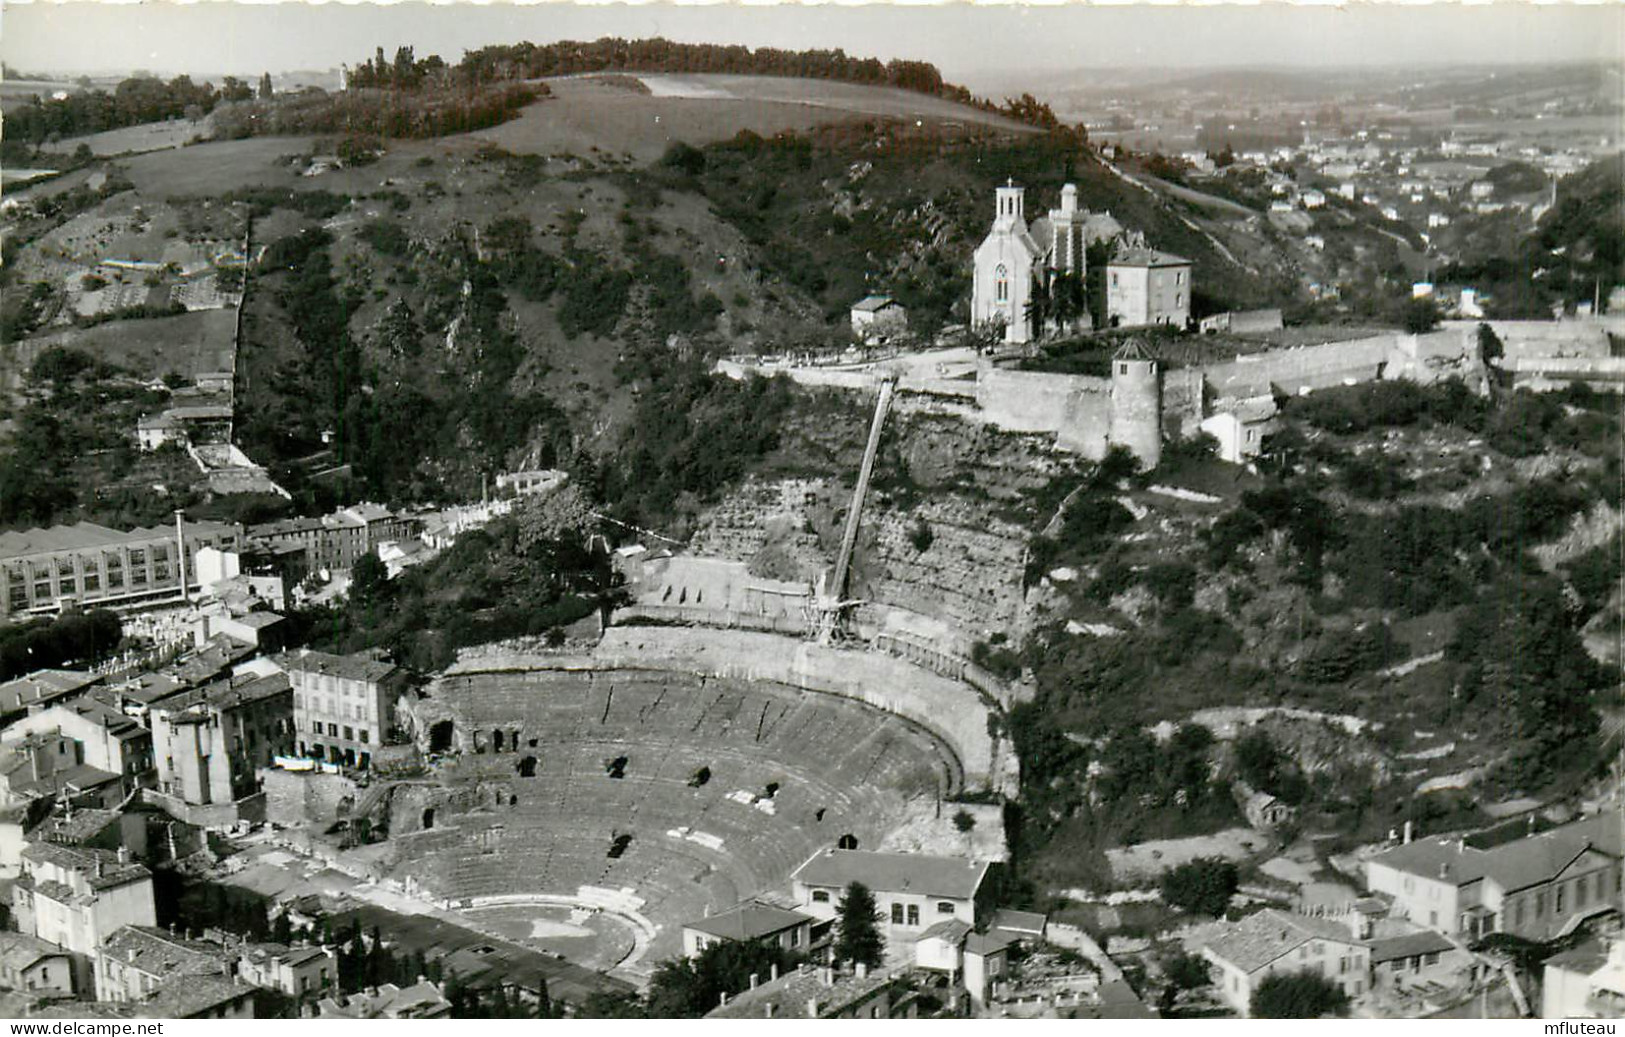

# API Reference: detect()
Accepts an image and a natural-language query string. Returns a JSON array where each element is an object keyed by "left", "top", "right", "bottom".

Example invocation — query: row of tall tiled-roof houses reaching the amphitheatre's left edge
[{"left": 0, "top": 637, "right": 408, "bottom": 832}]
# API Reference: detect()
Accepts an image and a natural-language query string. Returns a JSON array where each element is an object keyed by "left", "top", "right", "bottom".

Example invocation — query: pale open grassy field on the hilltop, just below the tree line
[{"left": 470, "top": 75, "right": 1025, "bottom": 163}]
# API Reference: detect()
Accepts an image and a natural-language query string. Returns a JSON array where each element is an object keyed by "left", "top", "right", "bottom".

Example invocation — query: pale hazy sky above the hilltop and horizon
[{"left": 0, "top": 0, "right": 1625, "bottom": 88}]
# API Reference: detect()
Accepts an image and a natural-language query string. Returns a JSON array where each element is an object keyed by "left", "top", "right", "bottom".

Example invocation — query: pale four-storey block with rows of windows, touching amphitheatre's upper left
[{"left": 275, "top": 649, "right": 406, "bottom": 769}]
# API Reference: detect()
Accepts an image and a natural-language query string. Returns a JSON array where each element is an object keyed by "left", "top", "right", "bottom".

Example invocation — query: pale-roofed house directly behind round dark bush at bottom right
[{"left": 1203, "top": 907, "right": 1372, "bottom": 1014}]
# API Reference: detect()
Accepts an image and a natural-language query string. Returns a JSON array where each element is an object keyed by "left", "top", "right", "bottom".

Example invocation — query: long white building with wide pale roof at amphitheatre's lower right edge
[{"left": 790, "top": 850, "right": 993, "bottom": 946}]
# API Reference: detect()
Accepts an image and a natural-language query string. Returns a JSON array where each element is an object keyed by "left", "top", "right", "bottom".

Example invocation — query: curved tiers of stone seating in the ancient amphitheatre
[{"left": 392, "top": 670, "right": 960, "bottom": 961}]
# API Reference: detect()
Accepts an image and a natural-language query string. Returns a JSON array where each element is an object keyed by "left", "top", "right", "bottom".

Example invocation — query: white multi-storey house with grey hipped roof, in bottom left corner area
[{"left": 11, "top": 842, "right": 158, "bottom": 991}]
